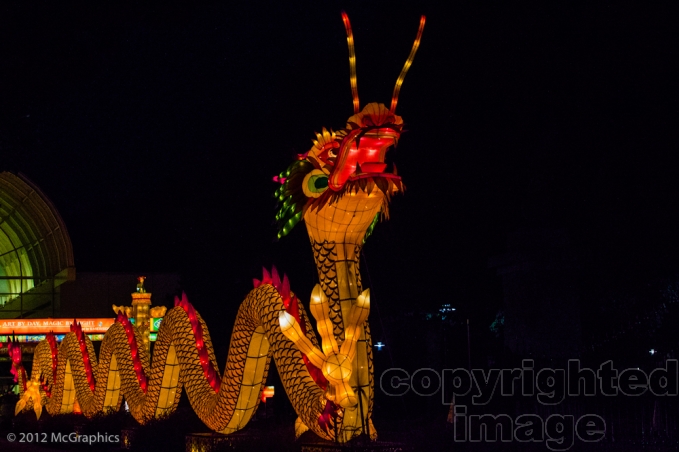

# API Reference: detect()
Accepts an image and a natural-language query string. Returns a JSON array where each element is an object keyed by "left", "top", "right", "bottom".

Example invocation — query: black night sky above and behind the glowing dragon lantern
[{"left": 0, "top": 1, "right": 679, "bottom": 350}]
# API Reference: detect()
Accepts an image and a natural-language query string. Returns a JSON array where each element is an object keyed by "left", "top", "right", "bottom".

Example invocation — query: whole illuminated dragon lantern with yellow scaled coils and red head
[{"left": 13, "top": 13, "right": 425, "bottom": 442}]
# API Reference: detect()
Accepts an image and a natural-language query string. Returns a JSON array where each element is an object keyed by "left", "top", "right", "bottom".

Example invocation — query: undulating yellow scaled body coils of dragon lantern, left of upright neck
[{"left": 19, "top": 284, "right": 328, "bottom": 437}]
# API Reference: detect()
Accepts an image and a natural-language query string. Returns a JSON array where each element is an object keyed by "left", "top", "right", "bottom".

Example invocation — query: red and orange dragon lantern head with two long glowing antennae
[{"left": 274, "top": 13, "right": 425, "bottom": 245}]
